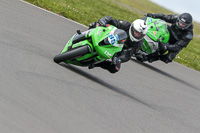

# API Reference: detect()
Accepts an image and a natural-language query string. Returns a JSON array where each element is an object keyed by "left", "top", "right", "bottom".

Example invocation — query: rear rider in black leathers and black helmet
[{"left": 147, "top": 13, "right": 193, "bottom": 63}]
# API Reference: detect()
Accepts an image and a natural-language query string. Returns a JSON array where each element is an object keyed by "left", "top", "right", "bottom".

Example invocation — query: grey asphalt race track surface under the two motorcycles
[{"left": 0, "top": 0, "right": 200, "bottom": 133}]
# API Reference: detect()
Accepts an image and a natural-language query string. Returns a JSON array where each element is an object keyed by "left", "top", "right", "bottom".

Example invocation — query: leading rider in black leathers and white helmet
[{"left": 89, "top": 16, "right": 147, "bottom": 73}]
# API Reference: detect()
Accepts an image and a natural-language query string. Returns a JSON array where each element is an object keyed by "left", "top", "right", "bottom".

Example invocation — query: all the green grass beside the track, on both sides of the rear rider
[{"left": 25, "top": 0, "right": 200, "bottom": 71}]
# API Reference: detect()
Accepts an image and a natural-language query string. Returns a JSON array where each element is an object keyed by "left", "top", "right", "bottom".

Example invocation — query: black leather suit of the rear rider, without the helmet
[{"left": 149, "top": 14, "right": 193, "bottom": 63}]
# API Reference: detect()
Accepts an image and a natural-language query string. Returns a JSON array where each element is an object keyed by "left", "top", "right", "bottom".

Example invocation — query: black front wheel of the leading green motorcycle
[{"left": 53, "top": 45, "right": 90, "bottom": 63}]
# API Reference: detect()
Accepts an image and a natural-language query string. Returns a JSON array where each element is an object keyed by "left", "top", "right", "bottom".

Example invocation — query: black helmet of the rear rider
[{"left": 176, "top": 13, "right": 192, "bottom": 30}]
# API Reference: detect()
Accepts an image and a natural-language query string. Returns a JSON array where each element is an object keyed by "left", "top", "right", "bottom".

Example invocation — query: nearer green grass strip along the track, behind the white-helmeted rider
[{"left": 26, "top": 0, "right": 139, "bottom": 26}]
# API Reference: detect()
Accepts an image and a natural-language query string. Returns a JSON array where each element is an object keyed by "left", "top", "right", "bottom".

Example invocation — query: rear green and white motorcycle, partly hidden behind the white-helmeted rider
[{"left": 134, "top": 17, "right": 170, "bottom": 61}]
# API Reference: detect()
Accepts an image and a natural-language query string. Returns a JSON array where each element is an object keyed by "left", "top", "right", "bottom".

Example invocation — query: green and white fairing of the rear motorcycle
[{"left": 142, "top": 17, "right": 170, "bottom": 54}]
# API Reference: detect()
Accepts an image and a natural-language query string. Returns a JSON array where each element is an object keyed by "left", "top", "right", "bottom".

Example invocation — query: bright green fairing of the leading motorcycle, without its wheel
[{"left": 55, "top": 25, "right": 126, "bottom": 66}]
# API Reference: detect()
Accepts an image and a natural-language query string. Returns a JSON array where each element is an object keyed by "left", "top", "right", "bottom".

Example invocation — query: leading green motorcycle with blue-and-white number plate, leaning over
[{"left": 54, "top": 25, "right": 128, "bottom": 67}]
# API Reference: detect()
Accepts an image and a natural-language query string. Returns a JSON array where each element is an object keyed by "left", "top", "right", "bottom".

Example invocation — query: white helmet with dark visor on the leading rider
[{"left": 129, "top": 19, "right": 147, "bottom": 42}]
